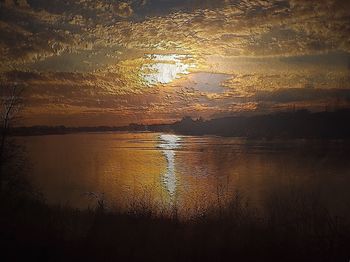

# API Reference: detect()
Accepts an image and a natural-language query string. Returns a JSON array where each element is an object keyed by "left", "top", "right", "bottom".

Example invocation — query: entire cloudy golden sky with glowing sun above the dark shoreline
[{"left": 0, "top": 0, "right": 350, "bottom": 126}]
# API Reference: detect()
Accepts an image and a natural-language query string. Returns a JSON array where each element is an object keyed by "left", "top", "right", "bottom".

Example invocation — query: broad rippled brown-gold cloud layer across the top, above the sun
[{"left": 0, "top": 0, "right": 350, "bottom": 70}]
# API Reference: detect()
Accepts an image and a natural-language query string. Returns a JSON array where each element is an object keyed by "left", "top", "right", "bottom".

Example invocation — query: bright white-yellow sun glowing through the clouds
[{"left": 141, "top": 54, "right": 195, "bottom": 86}]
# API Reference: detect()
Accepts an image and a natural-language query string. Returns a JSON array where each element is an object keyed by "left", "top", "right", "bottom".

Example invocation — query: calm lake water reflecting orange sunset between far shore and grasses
[{"left": 19, "top": 133, "right": 350, "bottom": 214}]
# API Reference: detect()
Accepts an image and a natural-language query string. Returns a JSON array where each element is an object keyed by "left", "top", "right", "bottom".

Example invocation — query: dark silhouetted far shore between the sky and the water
[{"left": 6, "top": 110, "right": 350, "bottom": 139}]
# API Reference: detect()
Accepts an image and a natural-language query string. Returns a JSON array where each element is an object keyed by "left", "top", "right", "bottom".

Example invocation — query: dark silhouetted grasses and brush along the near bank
[{"left": 0, "top": 183, "right": 350, "bottom": 261}]
